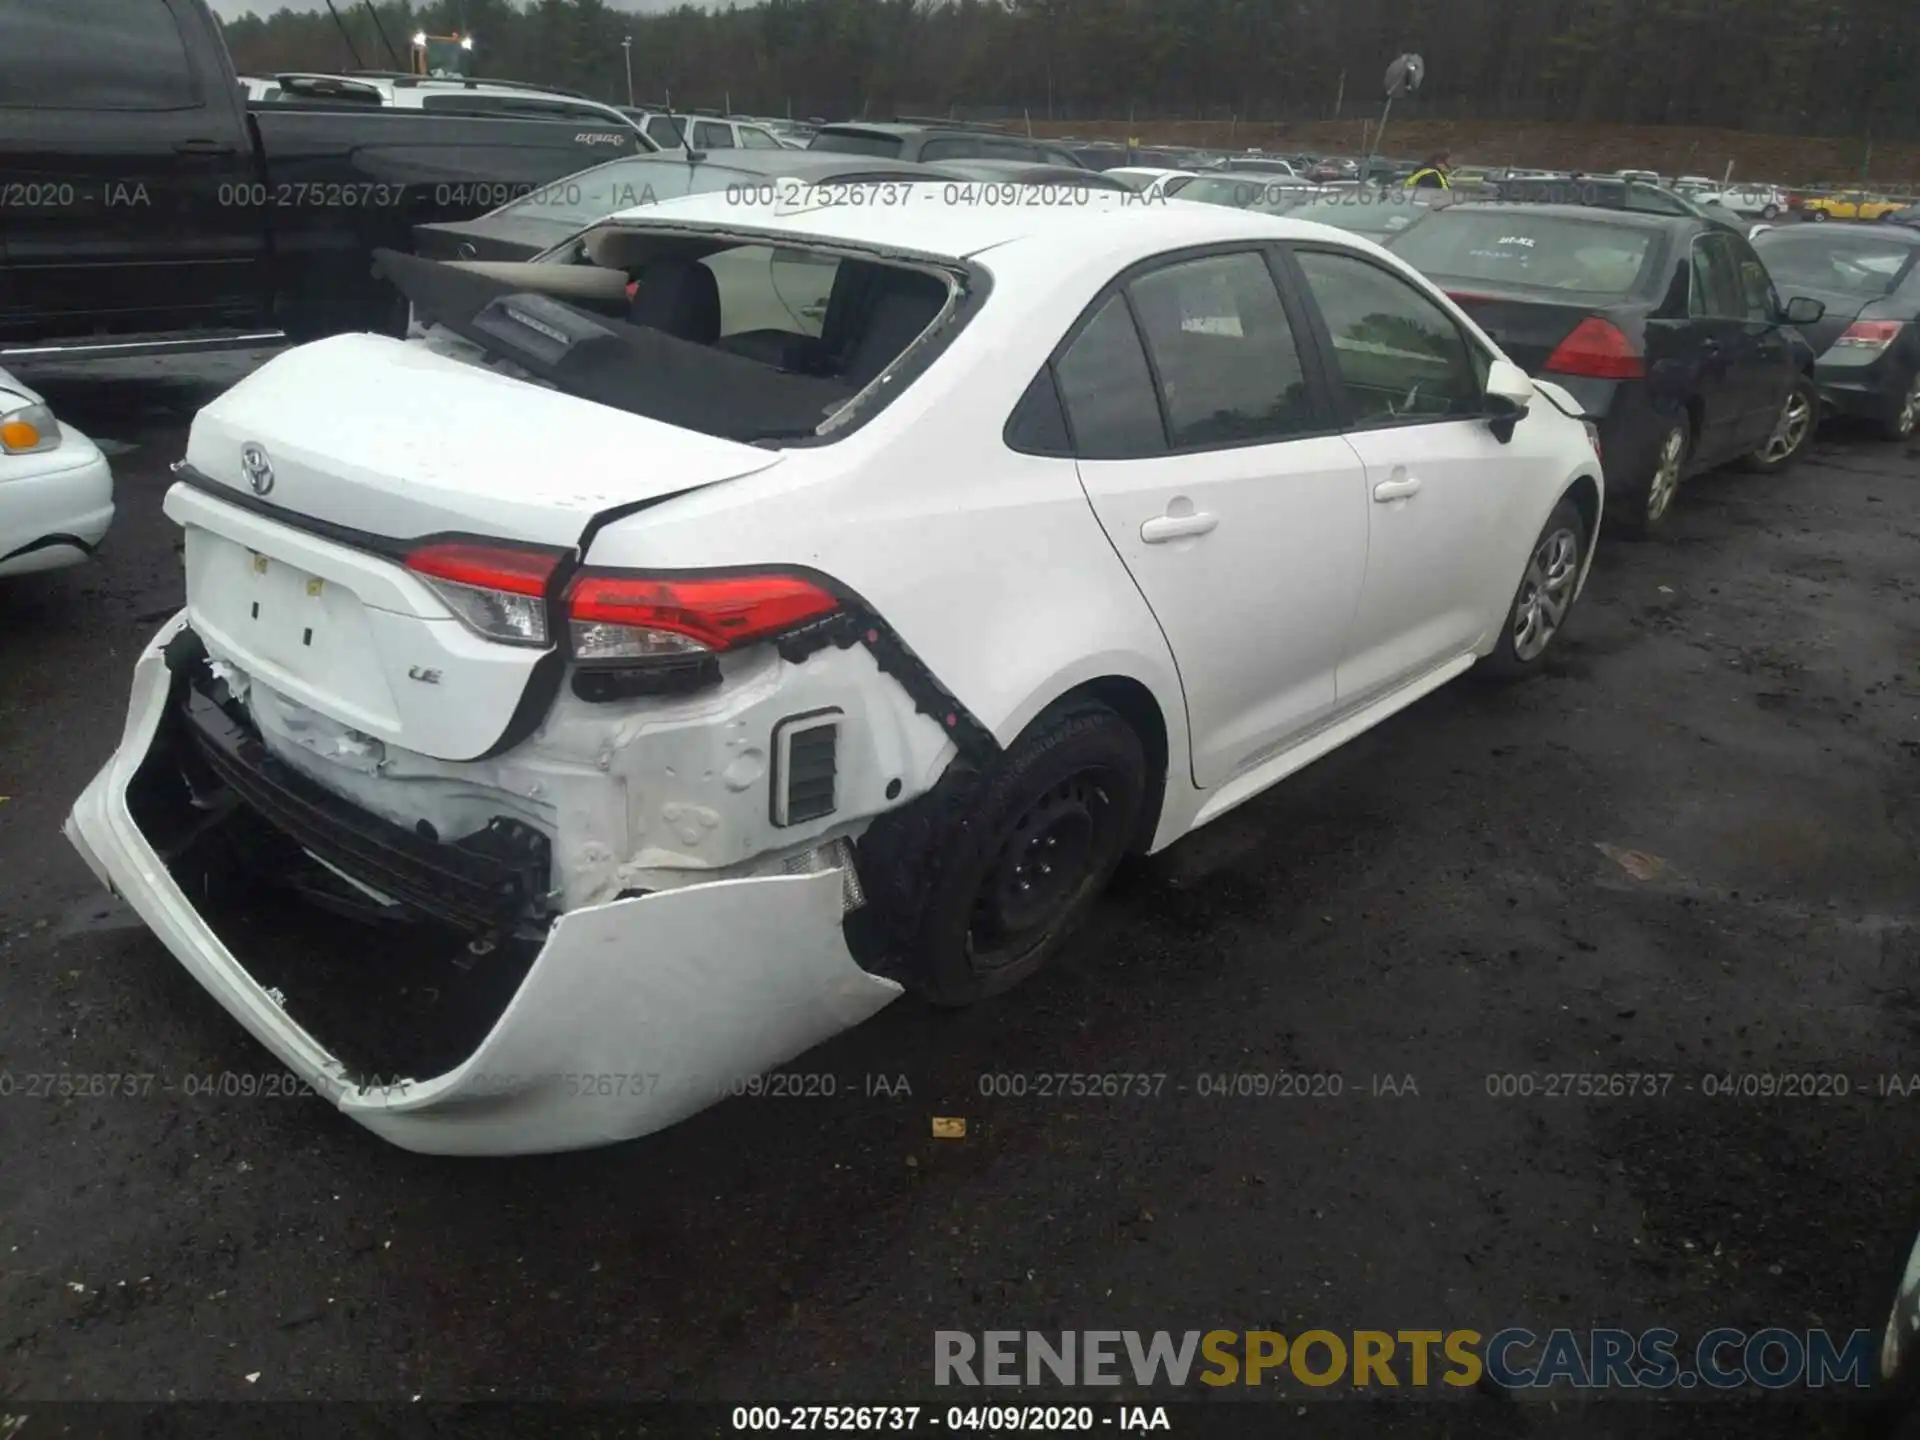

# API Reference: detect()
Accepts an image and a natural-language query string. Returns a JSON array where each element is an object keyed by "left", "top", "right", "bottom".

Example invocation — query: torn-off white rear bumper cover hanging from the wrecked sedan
[{"left": 65, "top": 614, "right": 900, "bottom": 1154}]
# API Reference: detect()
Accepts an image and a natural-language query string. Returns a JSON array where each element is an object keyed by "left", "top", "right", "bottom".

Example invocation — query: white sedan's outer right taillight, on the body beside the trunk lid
[{"left": 566, "top": 570, "right": 839, "bottom": 662}]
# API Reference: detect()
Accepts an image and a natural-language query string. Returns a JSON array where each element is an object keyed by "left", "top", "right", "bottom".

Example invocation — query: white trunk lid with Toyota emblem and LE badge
[{"left": 167, "top": 336, "right": 781, "bottom": 768}]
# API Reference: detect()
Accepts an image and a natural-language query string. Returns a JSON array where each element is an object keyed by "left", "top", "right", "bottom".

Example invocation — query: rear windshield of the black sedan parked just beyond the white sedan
[{"left": 1388, "top": 205, "right": 1659, "bottom": 298}]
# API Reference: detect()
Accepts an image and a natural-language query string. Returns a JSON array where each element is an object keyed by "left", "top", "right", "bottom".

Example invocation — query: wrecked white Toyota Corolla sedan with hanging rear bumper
[{"left": 67, "top": 184, "right": 1601, "bottom": 1154}]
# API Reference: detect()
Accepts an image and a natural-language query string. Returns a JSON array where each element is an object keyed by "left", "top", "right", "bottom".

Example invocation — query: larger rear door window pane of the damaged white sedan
[{"left": 1131, "top": 253, "right": 1315, "bottom": 449}]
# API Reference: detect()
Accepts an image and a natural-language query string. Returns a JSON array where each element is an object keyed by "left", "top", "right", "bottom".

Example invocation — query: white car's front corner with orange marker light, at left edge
[{"left": 0, "top": 371, "right": 113, "bottom": 576}]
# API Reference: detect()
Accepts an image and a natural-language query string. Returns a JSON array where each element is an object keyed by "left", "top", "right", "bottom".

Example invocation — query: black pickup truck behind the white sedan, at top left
[{"left": 0, "top": 0, "right": 653, "bottom": 365}]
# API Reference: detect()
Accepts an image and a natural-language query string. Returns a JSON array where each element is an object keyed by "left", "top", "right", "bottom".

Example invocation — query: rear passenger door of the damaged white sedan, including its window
[{"left": 1054, "top": 248, "right": 1367, "bottom": 787}]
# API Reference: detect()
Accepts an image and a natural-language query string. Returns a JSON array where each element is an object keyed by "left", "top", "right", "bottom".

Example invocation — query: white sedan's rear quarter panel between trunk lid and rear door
[{"left": 588, "top": 263, "right": 1187, "bottom": 844}]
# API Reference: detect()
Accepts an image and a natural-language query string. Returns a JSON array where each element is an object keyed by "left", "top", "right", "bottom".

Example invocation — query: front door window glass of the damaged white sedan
[{"left": 1296, "top": 250, "right": 1484, "bottom": 426}]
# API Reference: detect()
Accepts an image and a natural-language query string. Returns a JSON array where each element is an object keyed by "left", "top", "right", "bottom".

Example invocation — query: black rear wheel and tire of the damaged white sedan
[{"left": 904, "top": 701, "right": 1146, "bottom": 1008}]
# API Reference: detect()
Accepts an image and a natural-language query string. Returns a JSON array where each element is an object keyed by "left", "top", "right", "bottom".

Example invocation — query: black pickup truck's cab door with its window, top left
[{"left": 0, "top": 0, "right": 267, "bottom": 336}]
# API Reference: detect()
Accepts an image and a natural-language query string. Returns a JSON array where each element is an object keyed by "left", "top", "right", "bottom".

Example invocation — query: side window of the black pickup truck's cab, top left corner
[{"left": 0, "top": 0, "right": 200, "bottom": 109}]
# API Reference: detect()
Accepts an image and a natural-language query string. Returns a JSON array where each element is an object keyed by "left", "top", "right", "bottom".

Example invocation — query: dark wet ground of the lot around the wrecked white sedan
[{"left": 0, "top": 353, "right": 1920, "bottom": 1436}]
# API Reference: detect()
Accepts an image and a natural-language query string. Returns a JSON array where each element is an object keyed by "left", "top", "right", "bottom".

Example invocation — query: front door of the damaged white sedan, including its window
[{"left": 1292, "top": 246, "right": 1544, "bottom": 710}]
